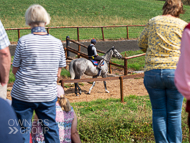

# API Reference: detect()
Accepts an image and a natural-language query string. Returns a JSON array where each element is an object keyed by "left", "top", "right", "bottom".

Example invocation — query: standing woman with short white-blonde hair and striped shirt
[{"left": 11, "top": 4, "right": 66, "bottom": 143}]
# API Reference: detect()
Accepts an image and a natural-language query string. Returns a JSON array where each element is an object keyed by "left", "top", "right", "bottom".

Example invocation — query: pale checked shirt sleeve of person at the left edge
[{"left": 0, "top": 21, "right": 10, "bottom": 50}]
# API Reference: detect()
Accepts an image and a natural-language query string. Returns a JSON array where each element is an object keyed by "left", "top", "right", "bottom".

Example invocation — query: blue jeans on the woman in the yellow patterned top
[{"left": 144, "top": 69, "right": 183, "bottom": 143}]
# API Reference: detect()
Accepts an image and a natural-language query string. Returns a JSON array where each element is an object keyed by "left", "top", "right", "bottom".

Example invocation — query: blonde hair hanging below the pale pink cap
[{"left": 58, "top": 97, "right": 71, "bottom": 112}]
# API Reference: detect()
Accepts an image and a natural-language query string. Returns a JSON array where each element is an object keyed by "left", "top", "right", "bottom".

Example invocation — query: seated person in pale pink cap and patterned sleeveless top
[{"left": 31, "top": 85, "right": 81, "bottom": 143}]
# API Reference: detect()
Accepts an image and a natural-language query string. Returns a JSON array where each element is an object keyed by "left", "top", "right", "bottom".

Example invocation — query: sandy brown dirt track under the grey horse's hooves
[{"left": 7, "top": 69, "right": 148, "bottom": 102}]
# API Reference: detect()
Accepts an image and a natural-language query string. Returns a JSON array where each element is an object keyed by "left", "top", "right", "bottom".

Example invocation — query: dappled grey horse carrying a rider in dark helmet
[{"left": 69, "top": 46, "right": 122, "bottom": 96}]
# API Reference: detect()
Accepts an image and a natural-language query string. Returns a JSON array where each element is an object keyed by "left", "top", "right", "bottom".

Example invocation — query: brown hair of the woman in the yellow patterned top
[{"left": 162, "top": 0, "right": 185, "bottom": 17}]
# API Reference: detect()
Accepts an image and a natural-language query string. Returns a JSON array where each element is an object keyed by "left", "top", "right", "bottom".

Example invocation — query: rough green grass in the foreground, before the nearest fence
[{"left": 72, "top": 95, "right": 188, "bottom": 143}]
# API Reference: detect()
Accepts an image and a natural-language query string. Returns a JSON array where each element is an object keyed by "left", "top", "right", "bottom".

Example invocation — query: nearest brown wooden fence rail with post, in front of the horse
[{"left": 60, "top": 74, "right": 144, "bottom": 103}]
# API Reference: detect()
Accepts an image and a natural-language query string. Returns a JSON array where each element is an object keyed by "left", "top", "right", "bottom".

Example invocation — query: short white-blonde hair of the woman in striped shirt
[{"left": 25, "top": 4, "right": 51, "bottom": 25}]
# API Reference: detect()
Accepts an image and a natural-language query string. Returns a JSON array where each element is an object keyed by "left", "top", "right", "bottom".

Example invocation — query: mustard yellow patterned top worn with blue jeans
[{"left": 138, "top": 16, "right": 187, "bottom": 71}]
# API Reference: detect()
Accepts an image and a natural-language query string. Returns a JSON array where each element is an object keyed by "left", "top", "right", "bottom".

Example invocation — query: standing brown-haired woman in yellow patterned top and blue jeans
[{"left": 138, "top": 0, "right": 187, "bottom": 143}]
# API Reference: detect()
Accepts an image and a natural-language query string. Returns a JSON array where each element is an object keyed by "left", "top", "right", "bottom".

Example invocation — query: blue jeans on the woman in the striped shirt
[{"left": 12, "top": 98, "right": 60, "bottom": 143}]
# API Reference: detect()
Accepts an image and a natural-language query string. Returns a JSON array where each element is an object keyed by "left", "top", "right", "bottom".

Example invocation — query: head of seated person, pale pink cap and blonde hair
[{"left": 57, "top": 85, "right": 71, "bottom": 112}]
